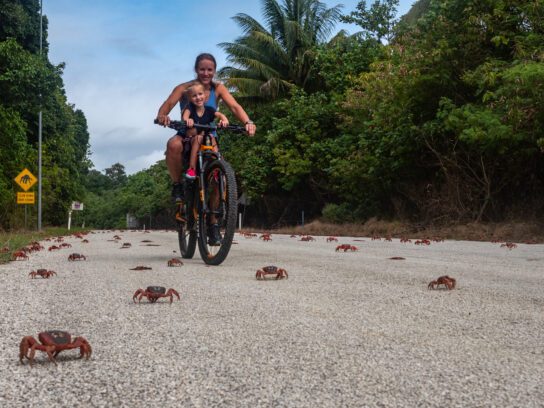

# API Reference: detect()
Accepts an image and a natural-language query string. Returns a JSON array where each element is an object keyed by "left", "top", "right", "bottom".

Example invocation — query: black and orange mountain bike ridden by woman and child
[{"left": 155, "top": 121, "right": 246, "bottom": 265}]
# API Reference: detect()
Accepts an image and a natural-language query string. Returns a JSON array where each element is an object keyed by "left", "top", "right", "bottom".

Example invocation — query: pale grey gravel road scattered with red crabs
[{"left": 0, "top": 231, "right": 544, "bottom": 408}]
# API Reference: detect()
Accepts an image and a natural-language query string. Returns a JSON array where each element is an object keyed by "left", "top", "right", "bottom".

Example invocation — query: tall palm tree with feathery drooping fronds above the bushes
[{"left": 219, "top": 0, "right": 342, "bottom": 98}]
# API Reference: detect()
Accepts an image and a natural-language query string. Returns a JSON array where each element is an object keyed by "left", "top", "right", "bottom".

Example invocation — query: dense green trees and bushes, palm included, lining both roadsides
[{"left": 0, "top": 0, "right": 544, "bottom": 228}]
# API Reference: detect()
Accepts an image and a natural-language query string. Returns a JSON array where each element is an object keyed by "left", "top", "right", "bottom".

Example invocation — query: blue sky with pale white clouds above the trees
[{"left": 42, "top": 0, "right": 415, "bottom": 174}]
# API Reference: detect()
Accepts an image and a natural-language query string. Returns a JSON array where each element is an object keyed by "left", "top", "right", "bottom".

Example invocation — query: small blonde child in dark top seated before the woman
[{"left": 181, "top": 83, "right": 229, "bottom": 180}]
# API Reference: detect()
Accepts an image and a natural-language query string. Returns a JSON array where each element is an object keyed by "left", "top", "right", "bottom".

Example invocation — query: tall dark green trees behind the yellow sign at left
[{"left": 0, "top": 0, "right": 91, "bottom": 228}]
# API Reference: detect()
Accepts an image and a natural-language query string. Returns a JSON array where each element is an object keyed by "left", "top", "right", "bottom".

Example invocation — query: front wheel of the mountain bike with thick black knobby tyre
[{"left": 198, "top": 160, "right": 238, "bottom": 265}]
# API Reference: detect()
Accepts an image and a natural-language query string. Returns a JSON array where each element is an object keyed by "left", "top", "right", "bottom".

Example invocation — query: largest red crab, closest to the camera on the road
[{"left": 19, "top": 330, "right": 92, "bottom": 367}]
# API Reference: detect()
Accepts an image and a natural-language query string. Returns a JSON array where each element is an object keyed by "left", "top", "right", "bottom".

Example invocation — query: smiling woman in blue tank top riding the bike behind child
[{"left": 157, "top": 54, "right": 256, "bottom": 202}]
